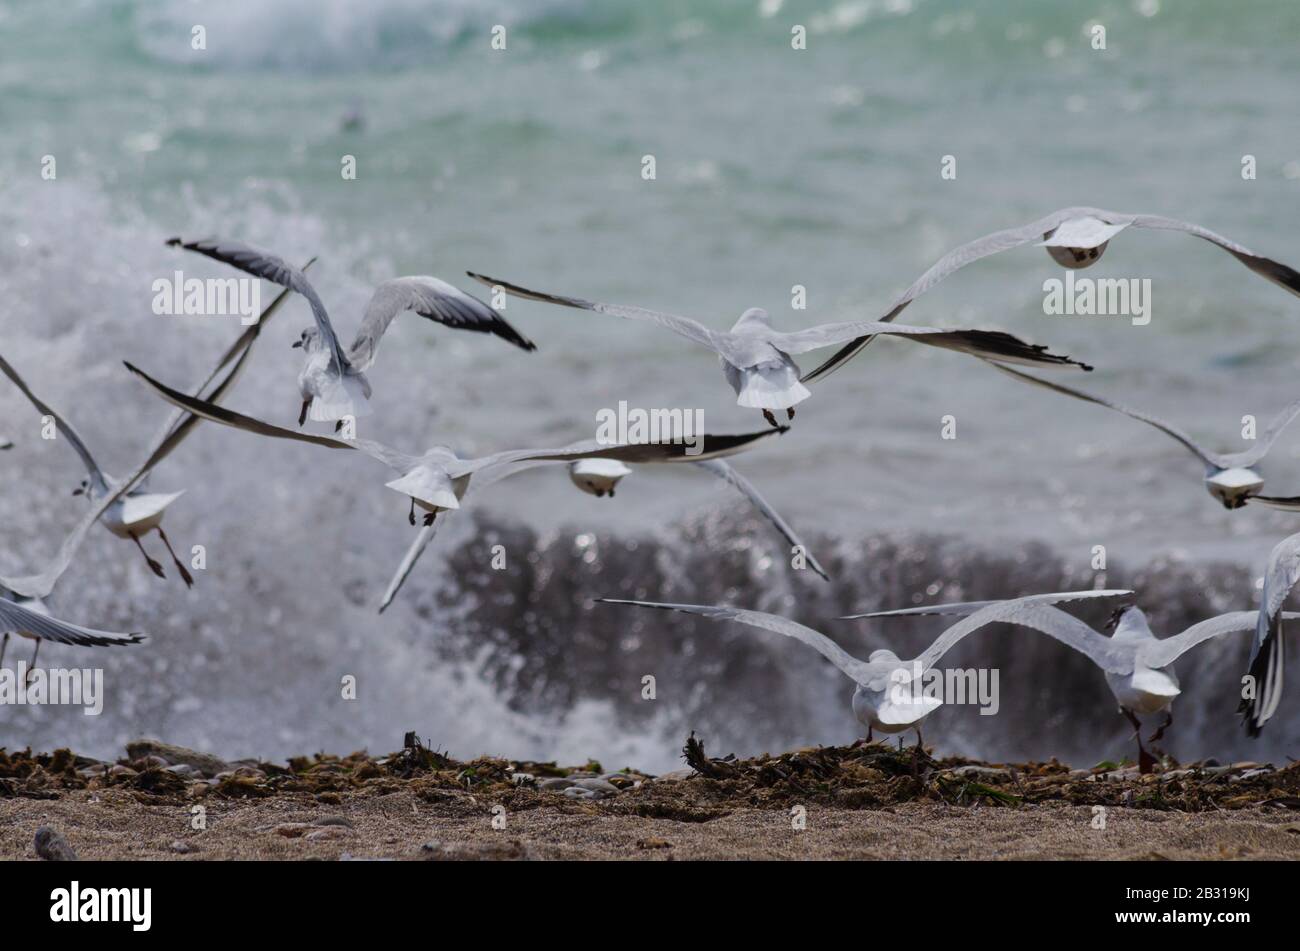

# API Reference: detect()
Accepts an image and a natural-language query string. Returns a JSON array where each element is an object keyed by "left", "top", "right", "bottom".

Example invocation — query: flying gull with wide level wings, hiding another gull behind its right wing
[{"left": 126, "top": 364, "right": 784, "bottom": 535}]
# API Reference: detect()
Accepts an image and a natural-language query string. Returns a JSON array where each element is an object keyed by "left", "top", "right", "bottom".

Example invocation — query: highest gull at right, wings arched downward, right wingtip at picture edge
[{"left": 802, "top": 208, "right": 1300, "bottom": 383}]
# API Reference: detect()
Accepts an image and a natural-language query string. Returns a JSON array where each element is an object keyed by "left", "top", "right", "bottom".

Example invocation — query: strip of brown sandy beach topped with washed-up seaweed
[{"left": 0, "top": 744, "right": 1300, "bottom": 860}]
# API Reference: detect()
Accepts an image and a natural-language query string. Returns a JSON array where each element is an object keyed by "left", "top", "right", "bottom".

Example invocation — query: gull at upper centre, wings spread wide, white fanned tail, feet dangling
[{"left": 467, "top": 272, "right": 1092, "bottom": 426}]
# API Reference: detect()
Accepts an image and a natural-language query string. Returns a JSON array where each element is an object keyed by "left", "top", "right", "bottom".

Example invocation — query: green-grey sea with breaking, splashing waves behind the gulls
[{"left": 0, "top": 0, "right": 1300, "bottom": 769}]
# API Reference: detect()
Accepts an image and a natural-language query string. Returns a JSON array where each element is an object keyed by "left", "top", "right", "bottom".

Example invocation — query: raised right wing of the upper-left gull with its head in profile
[{"left": 347, "top": 275, "right": 537, "bottom": 370}]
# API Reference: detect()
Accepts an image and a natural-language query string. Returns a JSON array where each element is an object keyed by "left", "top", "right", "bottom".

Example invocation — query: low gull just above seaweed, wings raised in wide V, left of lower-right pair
[{"left": 597, "top": 590, "right": 1132, "bottom": 746}]
